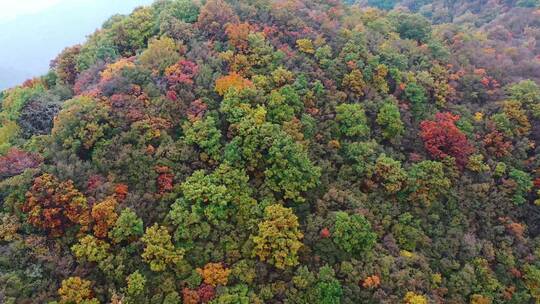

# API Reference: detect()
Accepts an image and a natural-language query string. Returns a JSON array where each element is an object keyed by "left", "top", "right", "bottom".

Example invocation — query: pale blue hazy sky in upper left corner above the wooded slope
[{"left": 0, "top": 0, "right": 153, "bottom": 90}]
